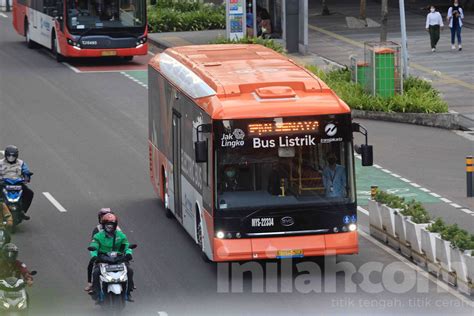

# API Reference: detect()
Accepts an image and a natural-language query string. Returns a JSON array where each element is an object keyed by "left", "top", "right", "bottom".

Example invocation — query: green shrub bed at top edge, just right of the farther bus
[{"left": 148, "top": 0, "right": 225, "bottom": 32}]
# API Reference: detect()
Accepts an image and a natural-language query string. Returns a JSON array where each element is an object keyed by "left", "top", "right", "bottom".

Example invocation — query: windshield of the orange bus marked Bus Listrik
[{"left": 215, "top": 116, "right": 355, "bottom": 211}]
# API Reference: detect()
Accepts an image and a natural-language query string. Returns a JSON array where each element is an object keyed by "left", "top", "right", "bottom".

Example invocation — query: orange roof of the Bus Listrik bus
[{"left": 150, "top": 44, "right": 350, "bottom": 119}]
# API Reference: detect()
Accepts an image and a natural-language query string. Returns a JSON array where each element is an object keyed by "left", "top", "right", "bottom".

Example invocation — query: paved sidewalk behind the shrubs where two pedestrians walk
[{"left": 149, "top": 0, "right": 474, "bottom": 129}]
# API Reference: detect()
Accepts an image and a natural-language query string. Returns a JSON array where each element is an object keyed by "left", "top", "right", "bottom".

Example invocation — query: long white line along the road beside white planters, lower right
[{"left": 358, "top": 225, "right": 474, "bottom": 307}]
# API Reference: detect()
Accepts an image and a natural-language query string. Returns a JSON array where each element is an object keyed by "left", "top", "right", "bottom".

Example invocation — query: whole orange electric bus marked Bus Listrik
[{"left": 148, "top": 45, "right": 372, "bottom": 261}]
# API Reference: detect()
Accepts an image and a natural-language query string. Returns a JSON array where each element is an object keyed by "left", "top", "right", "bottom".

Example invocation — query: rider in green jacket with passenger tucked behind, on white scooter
[{"left": 89, "top": 213, "right": 134, "bottom": 302}]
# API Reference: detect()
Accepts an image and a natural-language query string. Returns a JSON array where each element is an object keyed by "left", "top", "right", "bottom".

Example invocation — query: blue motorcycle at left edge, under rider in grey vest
[{"left": 3, "top": 173, "right": 33, "bottom": 232}]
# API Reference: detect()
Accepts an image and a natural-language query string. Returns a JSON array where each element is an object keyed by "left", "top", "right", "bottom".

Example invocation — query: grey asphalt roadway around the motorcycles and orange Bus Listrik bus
[{"left": 0, "top": 12, "right": 472, "bottom": 315}]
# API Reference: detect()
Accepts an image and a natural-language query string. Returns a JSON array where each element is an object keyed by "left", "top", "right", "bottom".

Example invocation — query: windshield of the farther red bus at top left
[{"left": 67, "top": 0, "right": 146, "bottom": 31}]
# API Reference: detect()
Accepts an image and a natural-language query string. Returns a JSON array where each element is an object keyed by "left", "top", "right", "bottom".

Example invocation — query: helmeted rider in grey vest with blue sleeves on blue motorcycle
[{"left": 0, "top": 145, "right": 34, "bottom": 220}]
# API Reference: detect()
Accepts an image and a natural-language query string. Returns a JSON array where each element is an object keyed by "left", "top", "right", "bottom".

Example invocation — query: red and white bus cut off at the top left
[{"left": 13, "top": 0, "right": 148, "bottom": 61}]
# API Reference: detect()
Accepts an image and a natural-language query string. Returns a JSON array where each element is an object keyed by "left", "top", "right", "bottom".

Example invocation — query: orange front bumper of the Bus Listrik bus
[{"left": 213, "top": 232, "right": 359, "bottom": 262}]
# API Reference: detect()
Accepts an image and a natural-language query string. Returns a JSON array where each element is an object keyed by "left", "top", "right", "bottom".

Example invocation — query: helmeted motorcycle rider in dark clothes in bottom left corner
[{"left": 0, "top": 243, "right": 33, "bottom": 286}]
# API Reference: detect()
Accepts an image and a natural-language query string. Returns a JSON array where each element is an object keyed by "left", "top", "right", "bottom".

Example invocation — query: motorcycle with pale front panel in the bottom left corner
[{"left": 0, "top": 271, "right": 36, "bottom": 315}]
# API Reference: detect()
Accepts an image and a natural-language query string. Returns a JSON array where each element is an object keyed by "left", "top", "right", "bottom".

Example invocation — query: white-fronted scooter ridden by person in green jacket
[{"left": 87, "top": 245, "right": 137, "bottom": 309}]
